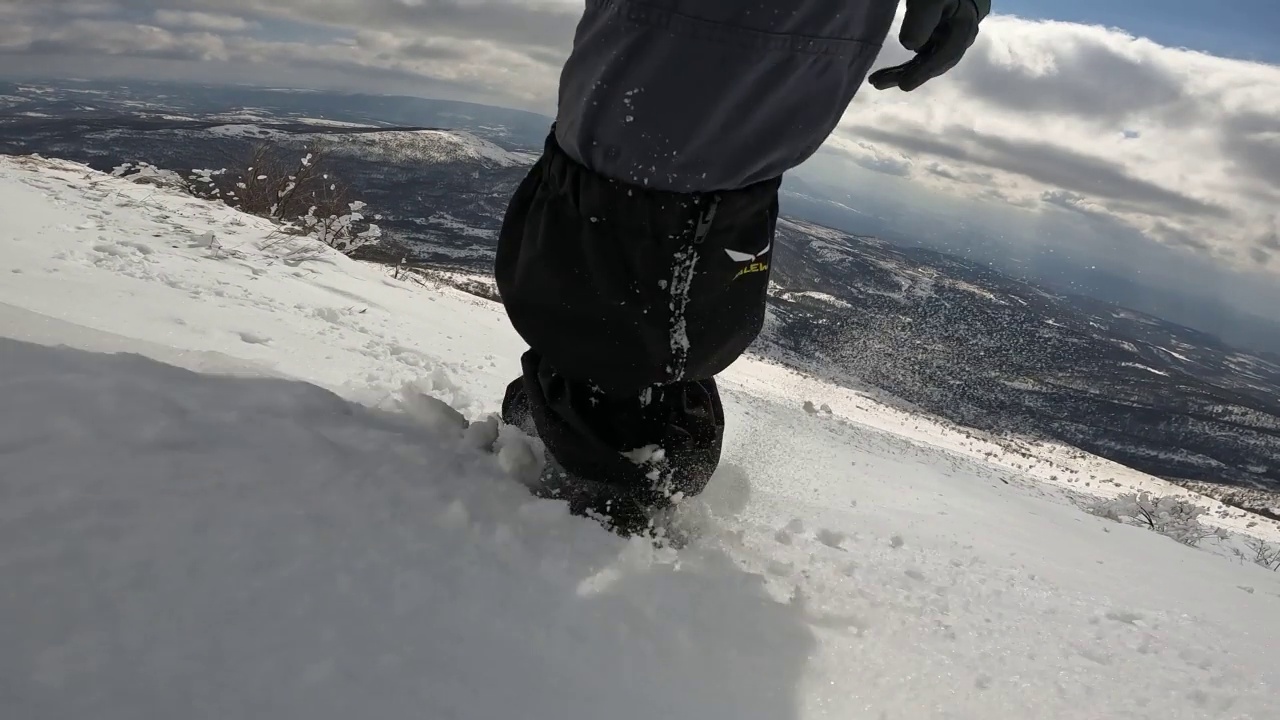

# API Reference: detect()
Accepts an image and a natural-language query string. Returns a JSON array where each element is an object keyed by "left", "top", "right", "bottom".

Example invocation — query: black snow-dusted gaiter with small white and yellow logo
[{"left": 494, "top": 131, "right": 780, "bottom": 505}]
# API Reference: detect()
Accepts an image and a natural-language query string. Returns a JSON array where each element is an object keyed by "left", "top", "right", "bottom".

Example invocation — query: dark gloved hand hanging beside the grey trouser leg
[{"left": 867, "top": 0, "right": 991, "bottom": 92}]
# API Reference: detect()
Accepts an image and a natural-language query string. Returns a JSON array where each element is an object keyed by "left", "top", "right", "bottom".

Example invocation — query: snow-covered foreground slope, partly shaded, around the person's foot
[{"left": 0, "top": 159, "right": 1280, "bottom": 720}]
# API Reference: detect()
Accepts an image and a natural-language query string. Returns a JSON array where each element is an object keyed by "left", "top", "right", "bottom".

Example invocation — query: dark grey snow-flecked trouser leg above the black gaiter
[{"left": 556, "top": 0, "right": 906, "bottom": 192}]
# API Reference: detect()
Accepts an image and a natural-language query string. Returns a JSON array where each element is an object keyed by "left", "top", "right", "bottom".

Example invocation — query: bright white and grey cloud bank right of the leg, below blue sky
[{"left": 837, "top": 15, "right": 1280, "bottom": 266}]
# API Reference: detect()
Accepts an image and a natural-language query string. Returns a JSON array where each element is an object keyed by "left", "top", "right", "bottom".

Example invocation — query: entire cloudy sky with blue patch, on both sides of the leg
[{"left": 0, "top": 0, "right": 1280, "bottom": 299}]
